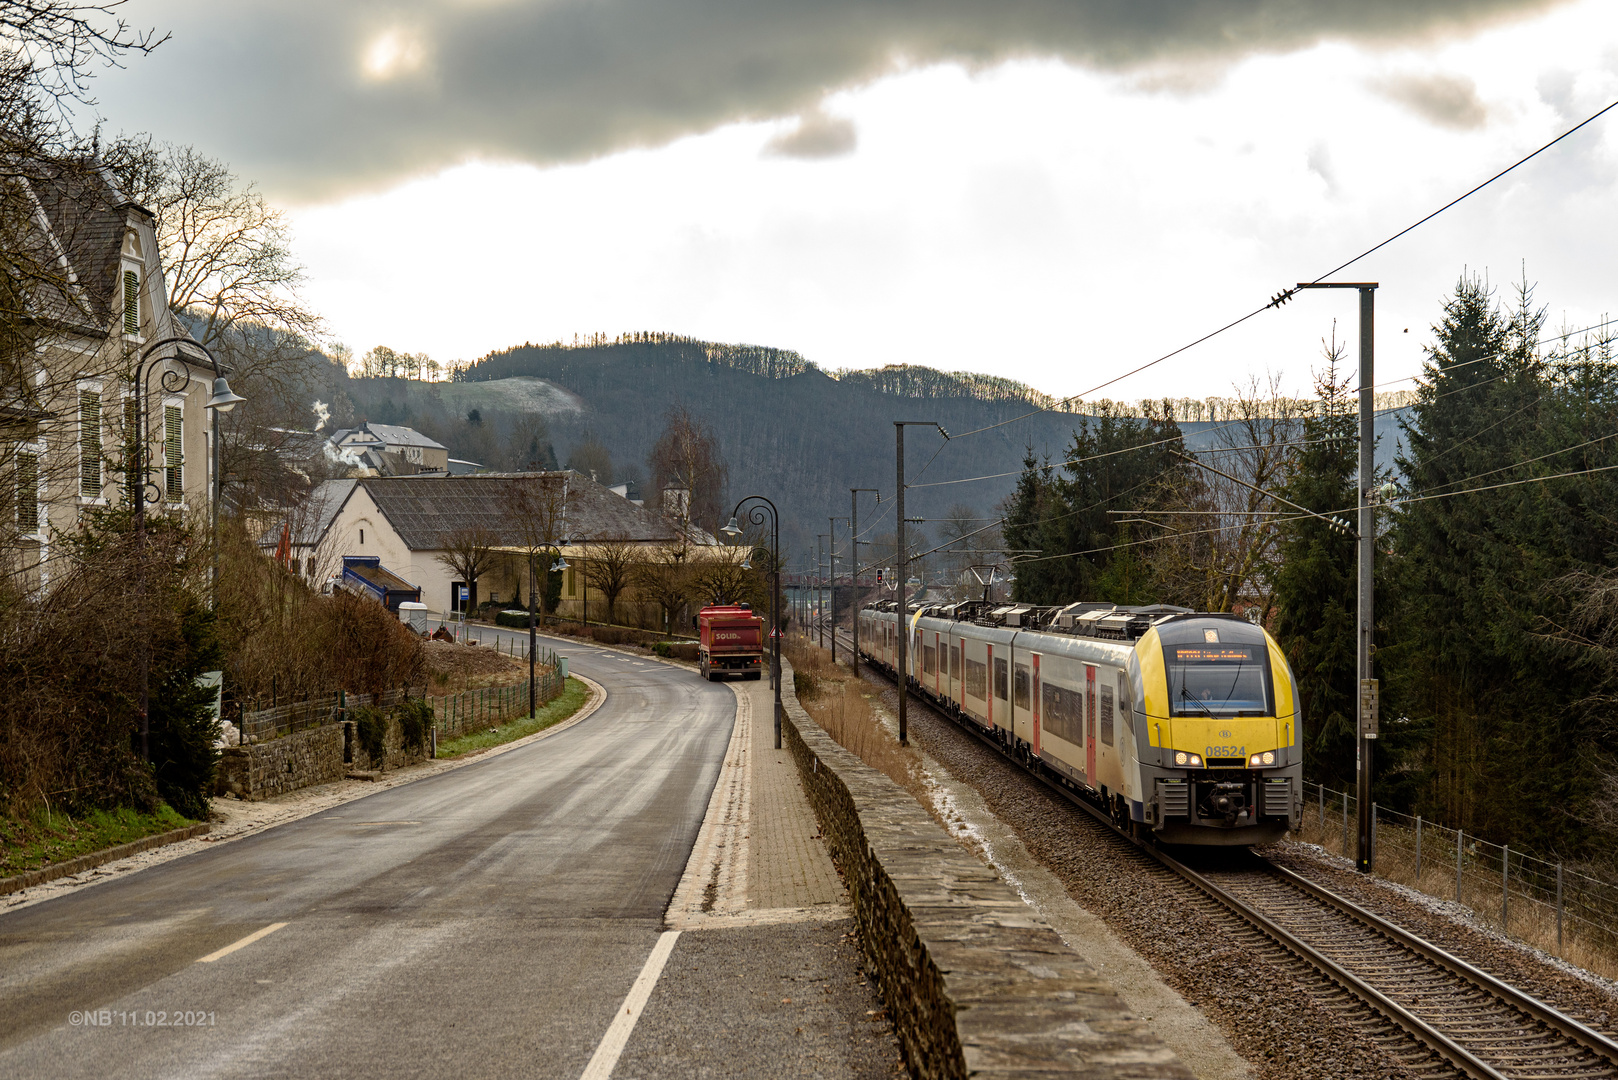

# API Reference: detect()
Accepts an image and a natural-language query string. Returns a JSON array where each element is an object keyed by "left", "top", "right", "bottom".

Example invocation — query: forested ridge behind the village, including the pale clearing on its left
[{"left": 331, "top": 334, "right": 1417, "bottom": 565}]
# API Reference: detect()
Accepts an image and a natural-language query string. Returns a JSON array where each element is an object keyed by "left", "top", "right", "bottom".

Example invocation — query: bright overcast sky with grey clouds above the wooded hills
[{"left": 85, "top": 0, "right": 1618, "bottom": 398}]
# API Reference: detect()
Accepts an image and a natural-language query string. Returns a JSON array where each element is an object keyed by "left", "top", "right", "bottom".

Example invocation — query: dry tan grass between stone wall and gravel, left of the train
[{"left": 781, "top": 635, "right": 932, "bottom": 810}]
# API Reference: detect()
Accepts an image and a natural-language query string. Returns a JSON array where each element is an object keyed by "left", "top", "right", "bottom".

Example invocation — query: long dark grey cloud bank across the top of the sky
[{"left": 114, "top": 0, "right": 1553, "bottom": 196}]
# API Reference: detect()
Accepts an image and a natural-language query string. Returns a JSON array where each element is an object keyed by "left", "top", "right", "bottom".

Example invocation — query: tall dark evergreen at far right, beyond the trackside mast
[{"left": 1377, "top": 279, "right": 1618, "bottom": 850}]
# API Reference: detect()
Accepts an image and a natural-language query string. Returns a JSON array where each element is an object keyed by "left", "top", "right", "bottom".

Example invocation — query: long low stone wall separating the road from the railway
[{"left": 781, "top": 661, "right": 1192, "bottom": 1080}]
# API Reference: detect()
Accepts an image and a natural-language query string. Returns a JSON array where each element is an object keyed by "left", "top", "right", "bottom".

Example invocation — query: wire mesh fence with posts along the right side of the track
[{"left": 1298, "top": 782, "right": 1618, "bottom": 967}]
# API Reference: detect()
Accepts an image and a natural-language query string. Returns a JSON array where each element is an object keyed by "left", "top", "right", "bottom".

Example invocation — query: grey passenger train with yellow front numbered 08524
[{"left": 859, "top": 601, "right": 1302, "bottom": 845}]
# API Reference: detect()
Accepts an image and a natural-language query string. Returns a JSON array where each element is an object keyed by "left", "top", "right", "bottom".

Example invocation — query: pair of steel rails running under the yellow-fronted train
[{"left": 841, "top": 625, "right": 1618, "bottom": 1080}]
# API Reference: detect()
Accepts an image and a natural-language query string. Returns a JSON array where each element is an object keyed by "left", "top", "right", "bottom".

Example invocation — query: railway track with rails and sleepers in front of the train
[{"left": 840, "top": 635, "right": 1618, "bottom": 1080}]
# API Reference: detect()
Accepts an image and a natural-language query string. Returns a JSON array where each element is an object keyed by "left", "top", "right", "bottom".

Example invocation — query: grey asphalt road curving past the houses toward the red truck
[{"left": 0, "top": 644, "right": 741, "bottom": 1077}]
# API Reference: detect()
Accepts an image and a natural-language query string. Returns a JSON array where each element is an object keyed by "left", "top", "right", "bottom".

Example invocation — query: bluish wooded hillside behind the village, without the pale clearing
[{"left": 460, "top": 335, "right": 1078, "bottom": 554}]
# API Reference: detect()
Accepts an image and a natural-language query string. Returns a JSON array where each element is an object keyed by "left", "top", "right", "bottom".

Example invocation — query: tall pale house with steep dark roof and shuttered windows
[{"left": 0, "top": 164, "right": 231, "bottom": 585}]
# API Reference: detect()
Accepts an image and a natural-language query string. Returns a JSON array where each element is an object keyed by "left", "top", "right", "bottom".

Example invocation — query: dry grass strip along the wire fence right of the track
[{"left": 1293, "top": 808, "right": 1618, "bottom": 978}]
